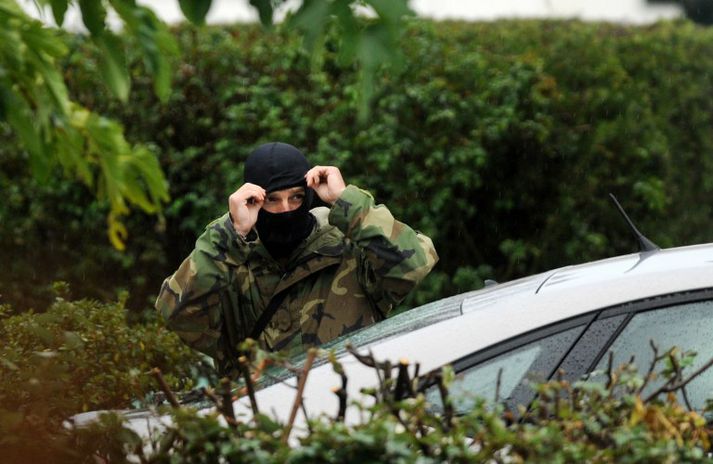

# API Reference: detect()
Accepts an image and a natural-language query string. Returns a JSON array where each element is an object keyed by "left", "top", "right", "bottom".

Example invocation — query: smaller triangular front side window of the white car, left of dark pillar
[{"left": 426, "top": 325, "right": 584, "bottom": 414}]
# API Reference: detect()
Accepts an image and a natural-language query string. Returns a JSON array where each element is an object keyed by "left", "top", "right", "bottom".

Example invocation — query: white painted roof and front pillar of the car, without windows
[{"left": 236, "top": 244, "right": 713, "bottom": 419}]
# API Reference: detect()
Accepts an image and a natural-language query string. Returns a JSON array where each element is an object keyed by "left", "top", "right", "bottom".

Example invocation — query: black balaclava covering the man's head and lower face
[{"left": 245, "top": 142, "right": 315, "bottom": 259}]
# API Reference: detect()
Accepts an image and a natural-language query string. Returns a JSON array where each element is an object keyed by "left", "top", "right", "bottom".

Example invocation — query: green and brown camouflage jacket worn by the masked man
[{"left": 156, "top": 185, "right": 438, "bottom": 374}]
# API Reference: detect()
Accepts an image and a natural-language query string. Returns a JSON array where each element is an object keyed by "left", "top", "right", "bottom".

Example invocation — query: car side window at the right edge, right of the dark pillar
[{"left": 596, "top": 301, "right": 713, "bottom": 409}]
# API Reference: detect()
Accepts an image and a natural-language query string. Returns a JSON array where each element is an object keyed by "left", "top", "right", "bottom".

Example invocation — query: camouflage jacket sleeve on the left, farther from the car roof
[{"left": 156, "top": 214, "right": 242, "bottom": 357}]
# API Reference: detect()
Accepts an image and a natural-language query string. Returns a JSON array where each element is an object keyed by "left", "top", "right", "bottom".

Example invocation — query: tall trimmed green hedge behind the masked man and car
[{"left": 0, "top": 21, "right": 713, "bottom": 310}]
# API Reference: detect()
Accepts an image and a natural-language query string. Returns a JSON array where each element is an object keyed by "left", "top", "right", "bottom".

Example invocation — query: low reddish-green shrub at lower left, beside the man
[{"left": 0, "top": 288, "right": 200, "bottom": 462}]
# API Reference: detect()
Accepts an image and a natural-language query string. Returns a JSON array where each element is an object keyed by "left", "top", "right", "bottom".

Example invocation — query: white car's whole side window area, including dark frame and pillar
[{"left": 426, "top": 289, "right": 713, "bottom": 412}]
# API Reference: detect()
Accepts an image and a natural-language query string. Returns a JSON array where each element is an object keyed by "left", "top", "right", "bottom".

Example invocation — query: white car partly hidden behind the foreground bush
[{"left": 74, "top": 239, "right": 713, "bottom": 434}]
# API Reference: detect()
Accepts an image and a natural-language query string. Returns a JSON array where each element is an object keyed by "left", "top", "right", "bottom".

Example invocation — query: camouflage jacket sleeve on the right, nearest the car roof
[{"left": 329, "top": 185, "right": 438, "bottom": 316}]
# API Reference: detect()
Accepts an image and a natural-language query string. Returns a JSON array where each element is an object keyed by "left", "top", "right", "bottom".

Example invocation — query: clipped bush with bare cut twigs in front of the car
[{"left": 16, "top": 338, "right": 713, "bottom": 464}]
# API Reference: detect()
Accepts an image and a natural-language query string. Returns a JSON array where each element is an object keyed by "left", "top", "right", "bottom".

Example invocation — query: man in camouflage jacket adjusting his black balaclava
[{"left": 156, "top": 143, "right": 438, "bottom": 375}]
